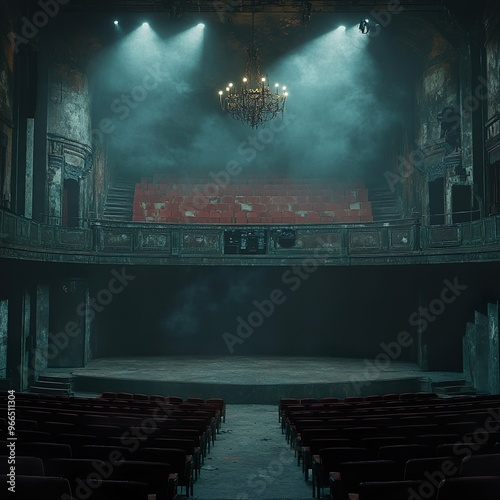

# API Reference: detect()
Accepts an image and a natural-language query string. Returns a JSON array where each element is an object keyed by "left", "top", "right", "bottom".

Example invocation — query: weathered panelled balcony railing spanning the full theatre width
[{"left": 0, "top": 210, "right": 500, "bottom": 265}]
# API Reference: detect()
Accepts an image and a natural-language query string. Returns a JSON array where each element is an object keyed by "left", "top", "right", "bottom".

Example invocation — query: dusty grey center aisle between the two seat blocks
[{"left": 193, "top": 405, "right": 318, "bottom": 500}]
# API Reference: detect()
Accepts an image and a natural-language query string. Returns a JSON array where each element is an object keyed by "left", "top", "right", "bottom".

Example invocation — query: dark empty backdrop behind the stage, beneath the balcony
[{"left": 92, "top": 266, "right": 491, "bottom": 371}]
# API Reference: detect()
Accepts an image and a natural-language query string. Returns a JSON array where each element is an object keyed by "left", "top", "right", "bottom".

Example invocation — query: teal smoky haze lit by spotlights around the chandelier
[{"left": 91, "top": 15, "right": 406, "bottom": 184}]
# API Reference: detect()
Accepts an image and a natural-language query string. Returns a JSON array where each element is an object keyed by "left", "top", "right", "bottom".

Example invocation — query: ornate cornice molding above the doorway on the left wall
[{"left": 47, "top": 134, "right": 93, "bottom": 181}]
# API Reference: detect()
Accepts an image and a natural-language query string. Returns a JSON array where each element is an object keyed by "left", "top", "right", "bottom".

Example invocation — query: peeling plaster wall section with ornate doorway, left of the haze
[{"left": 46, "top": 23, "right": 94, "bottom": 224}]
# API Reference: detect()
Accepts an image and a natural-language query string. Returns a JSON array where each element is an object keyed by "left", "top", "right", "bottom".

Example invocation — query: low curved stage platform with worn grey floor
[{"left": 44, "top": 356, "right": 463, "bottom": 404}]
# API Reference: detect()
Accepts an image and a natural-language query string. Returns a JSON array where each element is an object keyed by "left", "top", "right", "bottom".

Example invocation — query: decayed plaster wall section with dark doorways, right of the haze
[{"left": 399, "top": 33, "right": 479, "bottom": 224}]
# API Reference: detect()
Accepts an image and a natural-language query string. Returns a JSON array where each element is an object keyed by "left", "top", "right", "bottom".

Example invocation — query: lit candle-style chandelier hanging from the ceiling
[{"left": 219, "top": 3, "right": 288, "bottom": 128}]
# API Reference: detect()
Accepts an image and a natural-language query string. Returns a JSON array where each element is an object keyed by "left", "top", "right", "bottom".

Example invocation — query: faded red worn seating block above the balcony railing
[{"left": 133, "top": 176, "right": 373, "bottom": 224}]
